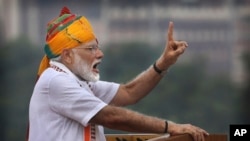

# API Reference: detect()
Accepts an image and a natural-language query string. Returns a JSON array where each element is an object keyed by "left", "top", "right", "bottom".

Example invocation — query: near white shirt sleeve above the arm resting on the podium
[{"left": 49, "top": 75, "right": 107, "bottom": 126}]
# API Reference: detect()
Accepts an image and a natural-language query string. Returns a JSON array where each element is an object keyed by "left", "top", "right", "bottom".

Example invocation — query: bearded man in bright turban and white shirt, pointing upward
[{"left": 29, "top": 7, "right": 208, "bottom": 141}]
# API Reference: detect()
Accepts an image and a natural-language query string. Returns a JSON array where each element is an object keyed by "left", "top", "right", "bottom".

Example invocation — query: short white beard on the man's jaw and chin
[{"left": 73, "top": 54, "right": 100, "bottom": 82}]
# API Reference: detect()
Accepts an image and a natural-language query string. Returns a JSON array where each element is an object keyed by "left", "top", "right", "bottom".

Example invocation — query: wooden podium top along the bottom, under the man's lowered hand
[{"left": 106, "top": 134, "right": 228, "bottom": 141}]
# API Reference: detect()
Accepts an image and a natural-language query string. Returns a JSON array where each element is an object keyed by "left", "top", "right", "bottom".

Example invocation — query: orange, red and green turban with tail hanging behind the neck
[{"left": 38, "top": 7, "right": 96, "bottom": 77}]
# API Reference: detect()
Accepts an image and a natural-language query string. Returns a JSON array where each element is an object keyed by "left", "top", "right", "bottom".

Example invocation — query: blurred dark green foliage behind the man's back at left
[{"left": 0, "top": 38, "right": 41, "bottom": 141}]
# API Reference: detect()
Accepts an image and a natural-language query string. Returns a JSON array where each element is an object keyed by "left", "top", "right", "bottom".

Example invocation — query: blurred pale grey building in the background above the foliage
[{"left": 0, "top": 0, "right": 250, "bottom": 82}]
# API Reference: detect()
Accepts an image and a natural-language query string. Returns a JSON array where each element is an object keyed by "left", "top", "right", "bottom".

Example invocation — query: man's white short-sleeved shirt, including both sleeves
[{"left": 29, "top": 61, "right": 119, "bottom": 141}]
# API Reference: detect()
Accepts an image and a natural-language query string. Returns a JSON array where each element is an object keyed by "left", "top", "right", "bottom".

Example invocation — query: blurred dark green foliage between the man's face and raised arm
[{"left": 101, "top": 43, "right": 160, "bottom": 83}]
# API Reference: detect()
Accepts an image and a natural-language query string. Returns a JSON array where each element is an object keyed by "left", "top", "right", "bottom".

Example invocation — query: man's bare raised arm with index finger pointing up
[{"left": 110, "top": 22, "right": 187, "bottom": 106}]
